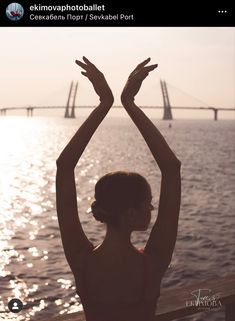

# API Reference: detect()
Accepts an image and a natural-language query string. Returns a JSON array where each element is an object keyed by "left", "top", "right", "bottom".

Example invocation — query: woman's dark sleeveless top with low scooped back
[{"left": 76, "top": 249, "right": 160, "bottom": 321}]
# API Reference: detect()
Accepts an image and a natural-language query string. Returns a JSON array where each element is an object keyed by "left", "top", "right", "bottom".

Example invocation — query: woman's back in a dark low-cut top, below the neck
[{"left": 74, "top": 246, "right": 161, "bottom": 321}]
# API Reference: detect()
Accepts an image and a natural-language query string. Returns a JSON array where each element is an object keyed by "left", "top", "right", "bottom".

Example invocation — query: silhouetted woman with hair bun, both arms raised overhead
[{"left": 56, "top": 57, "right": 181, "bottom": 321}]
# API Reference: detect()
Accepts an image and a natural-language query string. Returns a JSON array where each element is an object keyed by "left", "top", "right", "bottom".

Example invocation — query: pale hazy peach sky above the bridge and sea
[{"left": 0, "top": 27, "right": 235, "bottom": 119}]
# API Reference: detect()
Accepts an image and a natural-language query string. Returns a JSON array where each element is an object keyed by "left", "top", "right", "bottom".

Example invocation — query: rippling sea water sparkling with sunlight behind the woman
[{"left": 0, "top": 116, "right": 235, "bottom": 321}]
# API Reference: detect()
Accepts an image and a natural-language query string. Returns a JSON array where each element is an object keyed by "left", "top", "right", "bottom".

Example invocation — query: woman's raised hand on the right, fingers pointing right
[{"left": 121, "top": 58, "right": 158, "bottom": 105}]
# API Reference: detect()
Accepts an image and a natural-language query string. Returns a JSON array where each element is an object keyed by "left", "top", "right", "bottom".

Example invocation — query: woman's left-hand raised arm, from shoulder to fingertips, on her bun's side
[{"left": 56, "top": 57, "right": 113, "bottom": 269}]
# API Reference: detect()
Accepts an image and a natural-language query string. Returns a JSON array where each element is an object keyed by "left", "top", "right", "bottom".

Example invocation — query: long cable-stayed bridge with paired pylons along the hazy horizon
[{"left": 0, "top": 80, "right": 235, "bottom": 120}]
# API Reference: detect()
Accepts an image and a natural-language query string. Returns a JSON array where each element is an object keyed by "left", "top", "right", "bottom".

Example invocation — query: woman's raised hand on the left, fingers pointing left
[{"left": 76, "top": 57, "right": 114, "bottom": 106}]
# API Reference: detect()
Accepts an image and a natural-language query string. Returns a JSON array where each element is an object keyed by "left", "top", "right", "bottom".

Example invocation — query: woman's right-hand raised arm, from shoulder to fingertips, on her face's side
[{"left": 121, "top": 58, "right": 181, "bottom": 273}]
